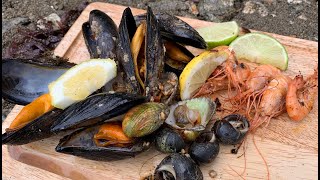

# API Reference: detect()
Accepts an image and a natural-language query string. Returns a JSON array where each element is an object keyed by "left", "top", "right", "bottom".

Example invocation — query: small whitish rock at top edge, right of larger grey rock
[{"left": 242, "top": 1, "right": 269, "bottom": 17}]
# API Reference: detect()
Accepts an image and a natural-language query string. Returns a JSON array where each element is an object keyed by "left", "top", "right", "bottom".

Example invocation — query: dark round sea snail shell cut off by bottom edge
[{"left": 154, "top": 153, "right": 203, "bottom": 180}]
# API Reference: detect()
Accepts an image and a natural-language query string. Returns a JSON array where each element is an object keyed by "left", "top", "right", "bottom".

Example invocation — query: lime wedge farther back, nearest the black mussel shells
[{"left": 197, "top": 21, "right": 239, "bottom": 49}]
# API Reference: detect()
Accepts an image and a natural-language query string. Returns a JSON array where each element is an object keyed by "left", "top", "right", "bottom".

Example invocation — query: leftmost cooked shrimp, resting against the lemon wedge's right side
[{"left": 193, "top": 48, "right": 251, "bottom": 97}]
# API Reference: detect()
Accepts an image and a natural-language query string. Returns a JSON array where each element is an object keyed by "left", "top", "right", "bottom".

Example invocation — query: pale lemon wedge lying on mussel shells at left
[{"left": 48, "top": 59, "right": 117, "bottom": 109}]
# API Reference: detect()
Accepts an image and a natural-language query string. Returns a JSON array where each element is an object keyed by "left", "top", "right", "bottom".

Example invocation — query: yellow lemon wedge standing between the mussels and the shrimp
[{"left": 179, "top": 46, "right": 231, "bottom": 100}]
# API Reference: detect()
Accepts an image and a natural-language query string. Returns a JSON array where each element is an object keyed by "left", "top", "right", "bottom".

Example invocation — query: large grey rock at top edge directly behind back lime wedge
[{"left": 198, "top": 0, "right": 242, "bottom": 22}]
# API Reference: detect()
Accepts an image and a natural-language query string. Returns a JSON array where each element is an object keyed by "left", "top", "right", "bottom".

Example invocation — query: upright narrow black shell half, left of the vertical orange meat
[{"left": 117, "top": 8, "right": 141, "bottom": 94}]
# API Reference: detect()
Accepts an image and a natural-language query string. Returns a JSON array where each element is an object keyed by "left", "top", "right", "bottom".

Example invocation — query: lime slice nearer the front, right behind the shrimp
[{"left": 230, "top": 33, "right": 288, "bottom": 70}]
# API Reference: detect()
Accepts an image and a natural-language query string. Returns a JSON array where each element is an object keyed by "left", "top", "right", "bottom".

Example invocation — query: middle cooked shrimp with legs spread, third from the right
[{"left": 231, "top": 65, "right": 281, "bottom": 117}]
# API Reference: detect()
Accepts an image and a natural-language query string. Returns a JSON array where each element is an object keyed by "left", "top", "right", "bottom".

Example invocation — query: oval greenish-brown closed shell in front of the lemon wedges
[{"left": 122, "top": 102, "right": 169, "bottom": 137}]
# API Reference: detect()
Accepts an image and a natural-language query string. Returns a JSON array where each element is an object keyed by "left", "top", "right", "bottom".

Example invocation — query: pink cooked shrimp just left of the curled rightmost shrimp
[{"left": 250, "top": 74, "right": 291, "bottom": 131}]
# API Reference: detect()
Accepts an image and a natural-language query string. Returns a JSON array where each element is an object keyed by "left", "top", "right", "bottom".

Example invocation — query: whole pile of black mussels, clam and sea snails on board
[{"left": 2, "top": 8, "right": 249, "bottom": 179}]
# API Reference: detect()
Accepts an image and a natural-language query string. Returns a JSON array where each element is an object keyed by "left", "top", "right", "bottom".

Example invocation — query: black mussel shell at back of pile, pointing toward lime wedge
[{"left": 135, "top": 13, "right": 207, "bottom": 49}]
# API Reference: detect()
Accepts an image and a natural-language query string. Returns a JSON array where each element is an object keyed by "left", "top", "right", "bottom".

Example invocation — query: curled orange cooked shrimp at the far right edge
[{"left": 286, "top": 68, "right": 318, "bottom": 121}]
